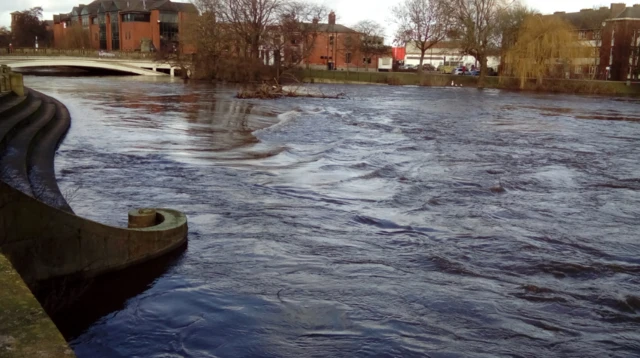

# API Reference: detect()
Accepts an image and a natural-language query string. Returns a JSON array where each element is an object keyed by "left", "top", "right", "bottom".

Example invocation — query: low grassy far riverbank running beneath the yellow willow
[{"left": 299, "top": 70, "right": 640, "bottom": 96}]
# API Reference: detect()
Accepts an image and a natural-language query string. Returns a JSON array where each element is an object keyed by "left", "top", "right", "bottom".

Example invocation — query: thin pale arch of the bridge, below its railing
[{"left": 1, "top": 58, "right": 166, "bottom": 76}]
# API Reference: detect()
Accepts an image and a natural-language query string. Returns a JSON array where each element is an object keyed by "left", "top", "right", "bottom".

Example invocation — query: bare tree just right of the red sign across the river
[{"left": 392, "top": 0, "right": 451, "bottom": 72}]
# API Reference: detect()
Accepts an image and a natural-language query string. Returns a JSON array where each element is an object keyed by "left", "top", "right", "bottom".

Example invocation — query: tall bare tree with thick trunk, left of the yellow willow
[{"left": 446, "top": 0, "right": 508, "bottom": 88}]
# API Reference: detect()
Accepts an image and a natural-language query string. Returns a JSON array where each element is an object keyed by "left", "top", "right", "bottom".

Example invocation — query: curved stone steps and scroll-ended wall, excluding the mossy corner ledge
[{"left": 0, "top": 79, "right": 188, "bottom": 287}]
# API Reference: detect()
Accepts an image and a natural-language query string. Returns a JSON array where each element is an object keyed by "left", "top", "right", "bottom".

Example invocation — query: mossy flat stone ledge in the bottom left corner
[{"left": 0, "top": 254, "right": 75, "bottom": 358}]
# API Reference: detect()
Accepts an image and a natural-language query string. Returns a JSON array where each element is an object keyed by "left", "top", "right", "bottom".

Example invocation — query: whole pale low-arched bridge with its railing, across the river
[{"left": 0, "top": 54, "right": 189, "bottom": 76}]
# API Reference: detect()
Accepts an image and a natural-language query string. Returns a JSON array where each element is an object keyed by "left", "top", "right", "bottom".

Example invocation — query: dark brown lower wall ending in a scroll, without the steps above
[{"left": 0, "top": 182, "right": 187, "bottom": 284}]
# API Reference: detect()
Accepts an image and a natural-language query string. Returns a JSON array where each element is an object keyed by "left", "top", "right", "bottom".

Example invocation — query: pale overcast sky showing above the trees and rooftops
[{"left": 0, "top": 0, "right": 640, "bottom": 42}]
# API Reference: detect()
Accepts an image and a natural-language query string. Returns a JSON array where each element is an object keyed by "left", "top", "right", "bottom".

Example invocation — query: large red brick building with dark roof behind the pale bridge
[{"left": 53, "top": 0, "right": 197, "bottom": 51}]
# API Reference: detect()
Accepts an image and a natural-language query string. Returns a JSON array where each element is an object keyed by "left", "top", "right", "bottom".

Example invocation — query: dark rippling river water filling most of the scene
[{"left": 25, "top": 76, "right": 640, "bottom": 358}]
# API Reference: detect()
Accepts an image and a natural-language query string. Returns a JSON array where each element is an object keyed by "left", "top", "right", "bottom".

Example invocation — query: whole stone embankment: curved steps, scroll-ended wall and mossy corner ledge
[{"left": 0, "top": 66, "right": 188, "bottom": 357}]
